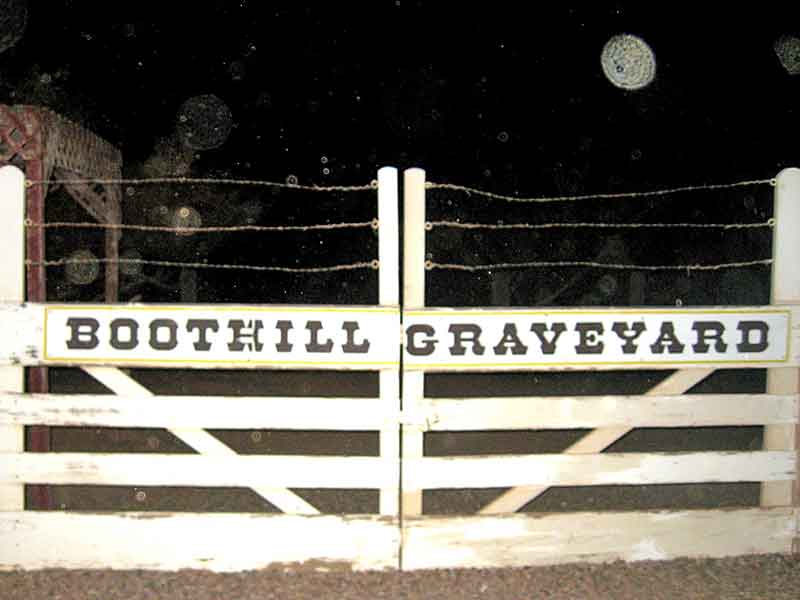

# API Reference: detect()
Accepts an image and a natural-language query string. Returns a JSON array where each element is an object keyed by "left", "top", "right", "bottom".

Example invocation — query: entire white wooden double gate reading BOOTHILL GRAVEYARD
[{"left": 0, "top": 168, "right": 800, "bottom": 571}]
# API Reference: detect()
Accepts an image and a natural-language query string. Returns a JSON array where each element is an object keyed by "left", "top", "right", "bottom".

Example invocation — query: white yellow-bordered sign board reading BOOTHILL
[{"left": 42, "top": 305, "right": 400, "bottom": 370}]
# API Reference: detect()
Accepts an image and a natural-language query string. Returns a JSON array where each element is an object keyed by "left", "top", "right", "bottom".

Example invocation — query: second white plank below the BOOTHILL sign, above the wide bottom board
[{"left": 0, "top": 452, "right": 396, "bottom": 488}]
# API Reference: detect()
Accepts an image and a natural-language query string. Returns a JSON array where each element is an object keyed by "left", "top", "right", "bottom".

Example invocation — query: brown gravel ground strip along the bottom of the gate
[{"left": 0, "top": 554, "right": 800, "bottom": 600}]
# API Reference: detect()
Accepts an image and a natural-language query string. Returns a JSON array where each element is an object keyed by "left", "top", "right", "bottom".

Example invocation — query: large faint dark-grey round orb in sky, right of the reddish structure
[{"left": 177, "top": 94, "right": 233, "bottom": 150}]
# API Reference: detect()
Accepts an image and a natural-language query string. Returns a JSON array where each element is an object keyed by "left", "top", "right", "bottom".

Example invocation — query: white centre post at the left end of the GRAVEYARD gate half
[{"left": 401, "top": 169, "right": 425, "bottom": 516}]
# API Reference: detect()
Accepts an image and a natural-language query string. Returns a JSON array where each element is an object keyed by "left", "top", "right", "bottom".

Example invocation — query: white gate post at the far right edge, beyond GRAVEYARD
[{"left": 761, "top": 168, "right": 800, "bottom": 520}]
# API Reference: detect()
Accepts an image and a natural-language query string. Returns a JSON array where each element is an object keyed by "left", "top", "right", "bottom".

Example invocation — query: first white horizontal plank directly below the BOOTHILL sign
[{"left": 0, "top": 394, "right": 388, "bottom": 431}]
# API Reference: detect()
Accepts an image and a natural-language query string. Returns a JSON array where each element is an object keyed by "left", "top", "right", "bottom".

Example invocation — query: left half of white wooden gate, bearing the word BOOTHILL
[{"left": 0, "top": 167, "right": 400, "bottom": 571}]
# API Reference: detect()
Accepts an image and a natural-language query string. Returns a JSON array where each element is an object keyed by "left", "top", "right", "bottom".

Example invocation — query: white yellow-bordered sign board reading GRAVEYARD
[{"left": 403, "top": 308, "right": 791, "bottom": 371}]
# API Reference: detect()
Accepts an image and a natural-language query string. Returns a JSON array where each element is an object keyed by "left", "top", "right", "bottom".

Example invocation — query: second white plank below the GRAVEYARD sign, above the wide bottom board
[{"left": 403, "top": 451, "right": 797, "bottom": 490}]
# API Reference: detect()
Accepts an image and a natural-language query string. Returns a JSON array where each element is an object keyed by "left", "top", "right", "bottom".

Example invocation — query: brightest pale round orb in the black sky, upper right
[{"left": 600, "top": 33, "right": 656, "bottom": 90}]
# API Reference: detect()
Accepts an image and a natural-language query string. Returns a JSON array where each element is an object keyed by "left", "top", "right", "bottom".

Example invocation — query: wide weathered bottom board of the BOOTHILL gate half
[{"left": 0, "top": 512, "right": 400, "bottom": 572}]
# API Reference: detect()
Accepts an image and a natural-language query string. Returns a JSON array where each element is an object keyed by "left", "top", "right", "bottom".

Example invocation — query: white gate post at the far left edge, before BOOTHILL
[{"left": 0, "top": 166, "right": 25, "bottom": 511}]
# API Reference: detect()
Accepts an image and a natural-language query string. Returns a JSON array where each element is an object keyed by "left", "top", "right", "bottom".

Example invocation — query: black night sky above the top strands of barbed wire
[{"left": 0, "top": 0, "right": 800, "bottom": 304}]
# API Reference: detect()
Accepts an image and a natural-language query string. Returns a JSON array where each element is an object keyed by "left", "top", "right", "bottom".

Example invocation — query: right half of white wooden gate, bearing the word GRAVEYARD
[{"left": 401, "top": 169, "right": 800, "bottom": 569}]
